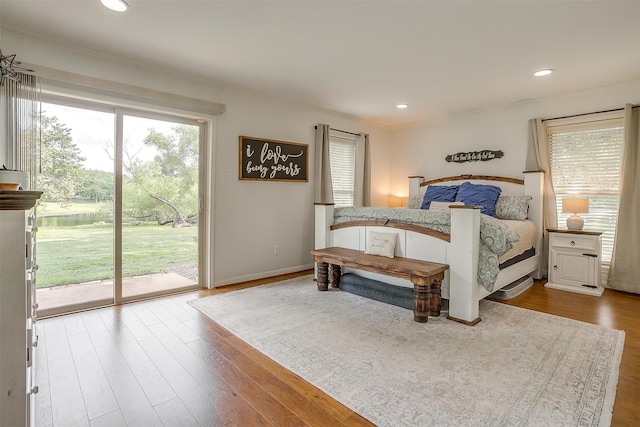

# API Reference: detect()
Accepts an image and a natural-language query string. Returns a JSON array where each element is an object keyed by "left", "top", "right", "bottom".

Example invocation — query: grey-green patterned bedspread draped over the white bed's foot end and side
[{"left": 334, "top": 207, "right": 528, "bottom": 292}]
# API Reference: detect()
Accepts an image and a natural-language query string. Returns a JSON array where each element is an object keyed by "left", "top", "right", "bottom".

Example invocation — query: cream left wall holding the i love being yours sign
[{"left": 0, "top": 33, "right": 391, "bottom": 285}]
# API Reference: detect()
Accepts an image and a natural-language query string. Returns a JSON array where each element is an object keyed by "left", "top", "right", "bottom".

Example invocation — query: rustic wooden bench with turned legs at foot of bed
[{"left": 311, "top": 248, "right": 449, "bottom": 323}]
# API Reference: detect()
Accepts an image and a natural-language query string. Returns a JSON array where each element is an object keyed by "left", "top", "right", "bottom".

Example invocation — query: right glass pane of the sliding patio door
[{"left": 121, "top": 115, "right": 200, "bottom": 299}]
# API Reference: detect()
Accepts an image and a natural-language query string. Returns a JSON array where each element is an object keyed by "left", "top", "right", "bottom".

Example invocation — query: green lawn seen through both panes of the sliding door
[{"left": 36, "top": 224, "right": 198, "bottom": 288}]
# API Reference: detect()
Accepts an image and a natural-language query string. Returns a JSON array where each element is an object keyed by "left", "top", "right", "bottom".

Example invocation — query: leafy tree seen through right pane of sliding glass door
[{"left": 124, "top": 125, "right": 199, "bottom": 227}]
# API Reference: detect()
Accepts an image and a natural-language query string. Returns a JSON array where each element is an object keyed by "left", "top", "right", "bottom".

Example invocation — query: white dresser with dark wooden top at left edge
[{"left": 0, "top": 191, "right": 42, "bottom": 427}]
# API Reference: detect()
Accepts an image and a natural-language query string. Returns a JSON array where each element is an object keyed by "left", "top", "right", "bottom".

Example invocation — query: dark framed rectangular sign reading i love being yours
[{"left": 238, "top": 136, "right": 309, "bottom": 182}]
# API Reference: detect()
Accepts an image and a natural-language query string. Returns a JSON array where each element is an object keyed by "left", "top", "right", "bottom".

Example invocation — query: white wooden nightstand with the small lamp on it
[{"left": 545, "top": 228, "right": 604, "bottom": 296}]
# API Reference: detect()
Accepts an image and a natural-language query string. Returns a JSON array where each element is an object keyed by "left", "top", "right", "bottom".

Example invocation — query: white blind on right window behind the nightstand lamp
[{"left": 547, "top": 119, "right": 623, "bottom": 263}]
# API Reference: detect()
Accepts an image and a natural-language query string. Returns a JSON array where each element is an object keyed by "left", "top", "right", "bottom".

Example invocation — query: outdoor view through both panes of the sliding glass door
[{"left": 36, "top": 99, "right": 201, "bottom": 315}]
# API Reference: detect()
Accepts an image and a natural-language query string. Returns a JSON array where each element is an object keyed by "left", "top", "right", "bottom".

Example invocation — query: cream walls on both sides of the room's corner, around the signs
[{"left": 0, "top": 33, "right": 640, "bottom": 284}]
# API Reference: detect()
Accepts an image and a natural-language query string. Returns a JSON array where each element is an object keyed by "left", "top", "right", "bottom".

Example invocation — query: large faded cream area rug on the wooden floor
[{"left": 190, "top": 276, "right": 624, "bottom": 427}]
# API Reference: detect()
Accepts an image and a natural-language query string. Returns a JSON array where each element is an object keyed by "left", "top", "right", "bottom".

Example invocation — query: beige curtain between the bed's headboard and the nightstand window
[{"left": 526, "top": 119, "right": 558, "bottom": 276}]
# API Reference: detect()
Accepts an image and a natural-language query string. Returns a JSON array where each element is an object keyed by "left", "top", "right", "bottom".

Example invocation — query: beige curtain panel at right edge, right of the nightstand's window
[{"left": 607, "top": 104, "right": 640, "bottom": 294}]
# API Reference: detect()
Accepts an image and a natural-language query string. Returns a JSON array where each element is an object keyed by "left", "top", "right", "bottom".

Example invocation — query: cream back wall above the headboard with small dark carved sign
[{"left": 390, "top": 80, "right": 640, "bottom": 195}]
